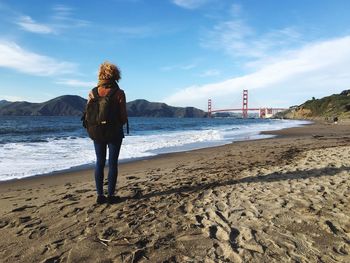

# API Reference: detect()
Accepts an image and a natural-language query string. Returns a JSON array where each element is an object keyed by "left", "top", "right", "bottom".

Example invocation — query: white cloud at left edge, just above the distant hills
[{"left": 0, "top": 40, "right": 76, "bottom": 76}]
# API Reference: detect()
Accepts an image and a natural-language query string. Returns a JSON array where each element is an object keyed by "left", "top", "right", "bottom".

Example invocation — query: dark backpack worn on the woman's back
[{"left": 82, "top": 87, "right": 122, "bottom": 143}]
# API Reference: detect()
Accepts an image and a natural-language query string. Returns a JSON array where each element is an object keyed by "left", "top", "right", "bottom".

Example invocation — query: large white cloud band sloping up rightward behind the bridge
[{"left": 164, "top": 36, "right": 350, "bottom": 108}]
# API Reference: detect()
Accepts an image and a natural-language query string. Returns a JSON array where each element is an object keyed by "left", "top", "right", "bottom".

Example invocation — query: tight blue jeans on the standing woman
[{"left": 94, "top": 138, "right": 123, "bottom": 196}]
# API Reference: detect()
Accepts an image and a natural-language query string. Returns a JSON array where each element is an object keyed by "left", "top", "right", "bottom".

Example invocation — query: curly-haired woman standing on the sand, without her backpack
[{"left": 88, "top": 62, "right": 128, "bottom": 204}]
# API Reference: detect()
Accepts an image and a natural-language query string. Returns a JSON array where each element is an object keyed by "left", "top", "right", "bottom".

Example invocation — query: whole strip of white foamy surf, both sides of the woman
[{"left": 0, "top": 120, "right": 312, "bottom": 181}]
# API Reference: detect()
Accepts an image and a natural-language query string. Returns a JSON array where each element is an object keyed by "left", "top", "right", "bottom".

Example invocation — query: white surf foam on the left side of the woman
[{"left": 0, "top": 138, "right": 95, "bottom": 180}]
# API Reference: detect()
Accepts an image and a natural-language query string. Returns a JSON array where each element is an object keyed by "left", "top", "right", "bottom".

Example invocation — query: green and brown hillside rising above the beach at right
[{"left": 277, "top": 90, "right": 350, "bottom": 120}]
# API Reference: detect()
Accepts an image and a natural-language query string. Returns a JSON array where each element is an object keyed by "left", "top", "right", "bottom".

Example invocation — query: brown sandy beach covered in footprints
[{"left": 0, "top": 124, "right": 350, "bottom": 263}]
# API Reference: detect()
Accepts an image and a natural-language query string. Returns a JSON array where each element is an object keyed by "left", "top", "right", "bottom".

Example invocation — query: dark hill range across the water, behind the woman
[{"left": 0, "top": 95, "right": 206, "bottom": 118}]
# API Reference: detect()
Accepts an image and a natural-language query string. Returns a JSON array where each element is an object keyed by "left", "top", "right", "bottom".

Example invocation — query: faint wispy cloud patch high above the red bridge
[{"left": 200, "top": 4, "right": 302, "bottom": 60}]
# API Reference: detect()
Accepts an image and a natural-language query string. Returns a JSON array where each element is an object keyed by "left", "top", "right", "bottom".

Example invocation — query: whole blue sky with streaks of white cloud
[{"left": 0, "top": 0, "right": 350, "bottom": 110}]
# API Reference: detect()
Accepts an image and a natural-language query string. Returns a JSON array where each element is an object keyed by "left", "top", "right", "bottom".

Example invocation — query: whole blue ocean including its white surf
[{"left": 0, "top": 116, "right": 307, "bottom": 181}]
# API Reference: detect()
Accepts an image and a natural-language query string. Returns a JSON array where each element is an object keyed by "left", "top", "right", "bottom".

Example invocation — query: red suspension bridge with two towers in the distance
[{"left": 208, "top": 90, "right": 287, "bottom": 118}]
